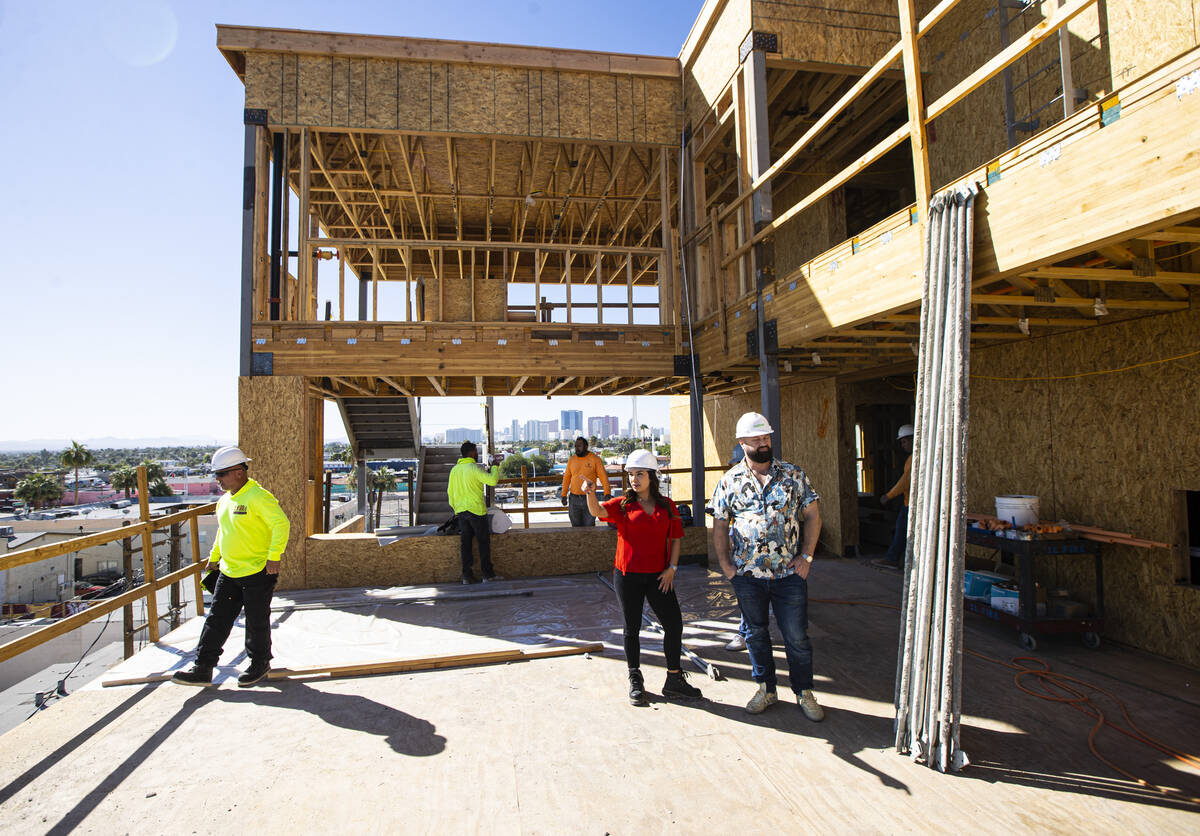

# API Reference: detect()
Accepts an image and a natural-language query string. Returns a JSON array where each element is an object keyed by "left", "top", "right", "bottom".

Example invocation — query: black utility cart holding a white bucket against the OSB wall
[{"left": 964, "top": 528, "right": 1104, "bottom": 650}]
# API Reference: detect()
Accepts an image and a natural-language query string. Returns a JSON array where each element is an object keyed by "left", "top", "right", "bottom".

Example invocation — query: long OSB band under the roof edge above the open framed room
[{"left": 245, "top": 52, "right": 686, "bottom": 145}]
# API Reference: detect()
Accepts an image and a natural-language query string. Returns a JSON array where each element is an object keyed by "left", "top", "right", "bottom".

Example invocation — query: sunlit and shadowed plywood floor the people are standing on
[{"left": 0, "top": 560, "right": 1200, "bottom": 834}]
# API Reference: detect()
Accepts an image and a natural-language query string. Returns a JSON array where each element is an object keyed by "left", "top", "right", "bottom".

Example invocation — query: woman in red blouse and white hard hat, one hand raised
[{"left": 582, "top": 450, "right": 701, "bottom": 705}]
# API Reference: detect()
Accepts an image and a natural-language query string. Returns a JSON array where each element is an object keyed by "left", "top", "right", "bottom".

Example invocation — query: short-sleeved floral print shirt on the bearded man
[{"left": 712, "top": 458, "right": 821, "bottom": 579}]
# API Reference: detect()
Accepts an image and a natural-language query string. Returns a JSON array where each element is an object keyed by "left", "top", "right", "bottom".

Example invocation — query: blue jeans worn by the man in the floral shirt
[{"left": 732, "top": 575, "right": 812, "bottom": 693}]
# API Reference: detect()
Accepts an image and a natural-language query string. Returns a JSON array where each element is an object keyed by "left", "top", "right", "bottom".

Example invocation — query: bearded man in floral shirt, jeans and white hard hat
[{"left": 712, "top": 413, "right": 824, "bottom": 721}]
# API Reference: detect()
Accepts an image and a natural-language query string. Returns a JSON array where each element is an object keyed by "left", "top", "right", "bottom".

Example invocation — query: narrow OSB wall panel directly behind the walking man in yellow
[{"left": 238, "top": 377, "right": 306, "bottom": 589}]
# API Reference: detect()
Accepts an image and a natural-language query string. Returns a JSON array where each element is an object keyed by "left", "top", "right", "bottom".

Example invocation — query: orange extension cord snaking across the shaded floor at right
[{"left": 809, "top": 599, "right": 1200, "bottom": 806}]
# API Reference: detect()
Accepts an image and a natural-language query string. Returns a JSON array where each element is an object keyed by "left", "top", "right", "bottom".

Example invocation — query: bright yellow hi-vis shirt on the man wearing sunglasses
[{"left": 209, "top": 479, "right": 292, "bottom": 578}]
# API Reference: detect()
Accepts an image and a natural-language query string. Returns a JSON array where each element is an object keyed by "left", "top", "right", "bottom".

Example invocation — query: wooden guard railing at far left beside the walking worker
[{"left": 0, "top": 467, "right": 216, "bottom": 662}]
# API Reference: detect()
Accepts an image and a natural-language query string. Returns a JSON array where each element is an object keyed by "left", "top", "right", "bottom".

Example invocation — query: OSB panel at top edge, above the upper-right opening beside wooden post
[{"left": 751, "top": 0, "right": 900, "bottom": 67}]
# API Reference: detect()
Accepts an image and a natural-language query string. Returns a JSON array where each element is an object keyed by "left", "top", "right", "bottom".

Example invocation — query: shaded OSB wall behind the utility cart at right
[{"left": 968, "top": 306, "right": 1200, "bottom": 666}]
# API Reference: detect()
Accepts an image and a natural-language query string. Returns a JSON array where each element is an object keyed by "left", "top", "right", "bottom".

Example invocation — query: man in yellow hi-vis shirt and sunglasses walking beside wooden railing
[{"left": 172, "top": 446, "right": 292, "bottom": 688}]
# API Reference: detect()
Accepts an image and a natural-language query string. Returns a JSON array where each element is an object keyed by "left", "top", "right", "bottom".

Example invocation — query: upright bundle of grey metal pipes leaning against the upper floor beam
[{"left": 895, "top": 184, "right": 978, "bottom": 772}]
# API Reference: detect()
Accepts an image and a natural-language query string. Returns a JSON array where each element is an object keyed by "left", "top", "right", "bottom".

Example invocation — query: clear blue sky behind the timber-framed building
[{"left": 0, "top": 0, "right": 702, "bottom": 441}]
